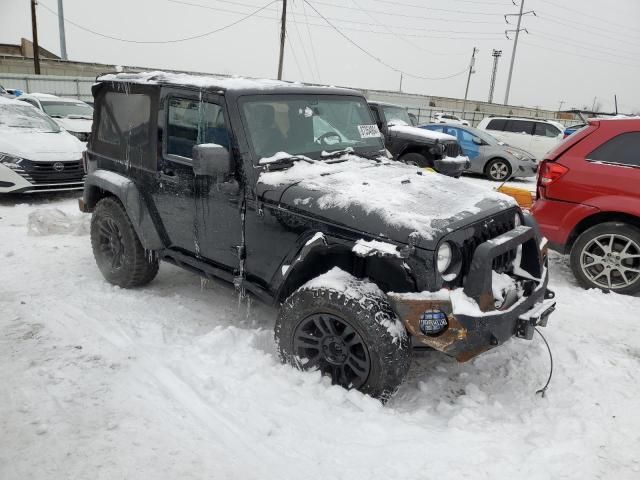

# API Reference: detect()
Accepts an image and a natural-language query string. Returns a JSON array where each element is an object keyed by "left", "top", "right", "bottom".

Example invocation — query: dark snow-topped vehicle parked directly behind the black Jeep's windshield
[{"left": 369, "top": 102, "right": 469, "bottom": 177}]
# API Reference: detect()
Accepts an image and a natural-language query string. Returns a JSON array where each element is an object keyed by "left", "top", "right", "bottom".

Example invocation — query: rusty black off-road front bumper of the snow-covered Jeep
[{"left": 388, "top": 224, "right": 555, "bottom": 362}]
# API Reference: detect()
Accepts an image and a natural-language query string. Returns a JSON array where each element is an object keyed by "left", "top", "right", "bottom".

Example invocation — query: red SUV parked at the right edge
[{"left": 532, "top": 118, "right": 640, "bottom": 294}]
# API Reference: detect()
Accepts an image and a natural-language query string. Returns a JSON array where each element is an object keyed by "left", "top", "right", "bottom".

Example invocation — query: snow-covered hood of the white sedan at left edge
[{"left": 0, "top": 128, "right": 84, "bottom": 162}]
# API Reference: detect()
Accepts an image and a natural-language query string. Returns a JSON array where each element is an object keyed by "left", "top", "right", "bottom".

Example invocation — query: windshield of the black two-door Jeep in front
[{"left": 241, "top": 95, "right": 384, "bottom": 159}]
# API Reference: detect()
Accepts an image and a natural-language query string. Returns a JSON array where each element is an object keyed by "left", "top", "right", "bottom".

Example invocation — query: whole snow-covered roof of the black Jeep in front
[{"left": 96, "top": 71, "right": 362, "bottom": 96}]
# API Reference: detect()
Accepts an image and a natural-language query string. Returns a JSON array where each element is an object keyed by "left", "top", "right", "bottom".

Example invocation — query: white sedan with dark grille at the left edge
[{"left": 0, "top": 98, "right": 84, "bottom": 193}]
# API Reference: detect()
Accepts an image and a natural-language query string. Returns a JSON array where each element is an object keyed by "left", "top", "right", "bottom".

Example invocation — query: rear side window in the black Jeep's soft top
[{"left": 94, "top": 92, "right": 154, "bottom": 167}]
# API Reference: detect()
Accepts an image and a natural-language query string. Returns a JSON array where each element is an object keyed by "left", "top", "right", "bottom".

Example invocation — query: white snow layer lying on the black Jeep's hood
[{"left": 259, "top": 155, "right": 516, "bottom": 239}]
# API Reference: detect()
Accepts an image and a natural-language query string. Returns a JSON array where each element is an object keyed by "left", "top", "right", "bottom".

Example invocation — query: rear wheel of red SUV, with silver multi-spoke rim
[{"left": 570, "top": 222, "right": 640, "bottom": 294}]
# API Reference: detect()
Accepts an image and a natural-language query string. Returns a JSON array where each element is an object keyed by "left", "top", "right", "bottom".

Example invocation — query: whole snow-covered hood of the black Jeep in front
[{"left": 258, "top": 155, "right": 515, "bottom": 249}]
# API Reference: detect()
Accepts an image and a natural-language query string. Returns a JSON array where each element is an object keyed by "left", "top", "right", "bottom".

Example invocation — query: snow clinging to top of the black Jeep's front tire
[{"left": 299, "top": 267, "right": 407, "bottom": 342}]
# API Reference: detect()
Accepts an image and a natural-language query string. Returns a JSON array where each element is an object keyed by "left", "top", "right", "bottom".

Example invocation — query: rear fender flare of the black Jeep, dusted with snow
[{"left": 82, "top": 169, "right": 165, "bottom": 250}]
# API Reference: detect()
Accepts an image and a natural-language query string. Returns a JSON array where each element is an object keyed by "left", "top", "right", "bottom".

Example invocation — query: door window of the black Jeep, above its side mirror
[{"left": 166, "top": 97, "right": 229, "bottom": 159}]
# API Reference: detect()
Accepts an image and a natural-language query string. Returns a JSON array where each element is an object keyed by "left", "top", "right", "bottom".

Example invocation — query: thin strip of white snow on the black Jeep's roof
[{"left": 98, "top": 71, "right": 302, "bottom": 90}]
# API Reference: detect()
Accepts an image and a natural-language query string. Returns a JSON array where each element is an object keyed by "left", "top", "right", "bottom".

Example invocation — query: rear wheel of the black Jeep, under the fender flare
[{"left": 91, "top": 197, "right": 159, "bottom": 288}]
